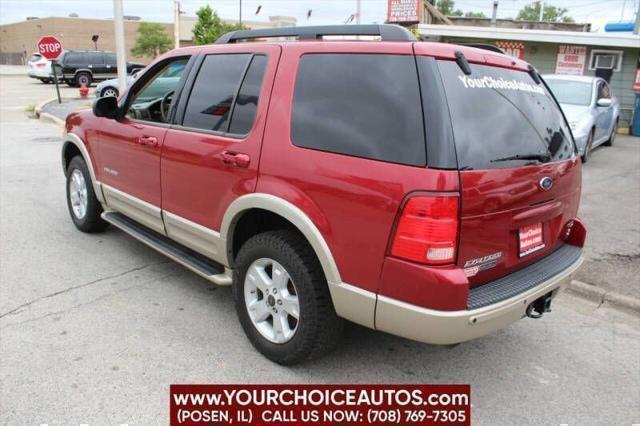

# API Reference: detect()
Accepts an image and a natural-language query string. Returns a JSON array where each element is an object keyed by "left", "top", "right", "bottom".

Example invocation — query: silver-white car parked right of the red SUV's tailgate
[{"left": 544, "top": 74, "right": 620, "bottom": 163}]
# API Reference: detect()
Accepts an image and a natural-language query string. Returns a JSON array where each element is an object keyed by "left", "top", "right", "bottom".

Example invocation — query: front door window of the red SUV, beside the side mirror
[{"left": 126, "top": 58, "right": 189, "bottom": 123}]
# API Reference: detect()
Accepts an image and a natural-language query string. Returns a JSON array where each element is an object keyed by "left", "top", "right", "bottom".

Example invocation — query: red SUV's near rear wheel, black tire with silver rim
[{"left": 233, "top": 230, "right": 344, "bottom": 365}]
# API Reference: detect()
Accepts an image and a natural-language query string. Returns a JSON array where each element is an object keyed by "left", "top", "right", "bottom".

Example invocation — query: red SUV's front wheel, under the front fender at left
[{"left": 66, "top": 156, "right": 109, "bottom": 233}]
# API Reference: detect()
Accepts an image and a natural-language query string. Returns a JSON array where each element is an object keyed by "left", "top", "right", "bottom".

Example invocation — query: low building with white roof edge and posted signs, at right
[{"left": 417, "top": 24, "right": 640, "bottom": 129}]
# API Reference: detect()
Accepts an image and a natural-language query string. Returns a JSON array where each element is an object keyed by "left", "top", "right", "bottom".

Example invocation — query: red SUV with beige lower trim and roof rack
[{"left": 62, "top": 25, "right": 586, "bottom": 364}]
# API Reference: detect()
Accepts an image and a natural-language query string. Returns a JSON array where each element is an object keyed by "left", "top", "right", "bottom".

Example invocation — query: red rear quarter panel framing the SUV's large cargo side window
[{"left": 257, "top": 42, "right": 458, "bottom": 292}]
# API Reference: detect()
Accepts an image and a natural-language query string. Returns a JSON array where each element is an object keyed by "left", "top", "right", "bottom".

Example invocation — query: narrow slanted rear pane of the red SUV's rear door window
[{"left": 229, "top": 55, "right": 267, "bottom": 135}]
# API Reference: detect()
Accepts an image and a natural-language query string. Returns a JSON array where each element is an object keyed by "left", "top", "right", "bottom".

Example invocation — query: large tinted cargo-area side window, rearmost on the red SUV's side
[{"left": 291, "top": 54, "right": 426, "bottom": 166}]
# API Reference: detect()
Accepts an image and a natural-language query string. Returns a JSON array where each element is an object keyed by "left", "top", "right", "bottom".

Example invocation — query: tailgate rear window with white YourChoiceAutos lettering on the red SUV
[{"left": 438, "top": 61, "right": 575, "bottom": 169}]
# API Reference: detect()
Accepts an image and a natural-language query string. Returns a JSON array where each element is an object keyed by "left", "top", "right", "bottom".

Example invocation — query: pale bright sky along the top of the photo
[{"left": 0, "top": 0, "right": 640, "bottom": 31}]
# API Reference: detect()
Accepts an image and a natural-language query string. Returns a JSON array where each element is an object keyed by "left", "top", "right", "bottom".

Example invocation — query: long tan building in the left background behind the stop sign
[{"left": 0, "top": 17, "right": 173, "bottom": 65}]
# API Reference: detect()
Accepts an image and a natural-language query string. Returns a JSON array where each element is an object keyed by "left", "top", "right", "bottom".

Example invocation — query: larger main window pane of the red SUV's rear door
[{"left": 182, "top": 53, "right": 251, "bottom": 132}]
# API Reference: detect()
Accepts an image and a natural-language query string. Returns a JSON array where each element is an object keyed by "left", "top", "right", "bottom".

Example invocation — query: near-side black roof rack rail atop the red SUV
[{"left": 216, "top": 24, "right": 416, "bottom": 44}]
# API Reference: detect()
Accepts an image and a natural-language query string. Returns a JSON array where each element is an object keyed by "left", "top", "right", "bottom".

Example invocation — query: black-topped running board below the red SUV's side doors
[{"left": 102, "top": 211, "right": 231, "bottom": 286}]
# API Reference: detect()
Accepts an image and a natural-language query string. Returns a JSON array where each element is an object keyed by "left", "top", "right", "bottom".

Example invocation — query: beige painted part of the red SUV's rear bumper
[{"left": 375, "top": 251, "right": 583, "bottom": 345}]
